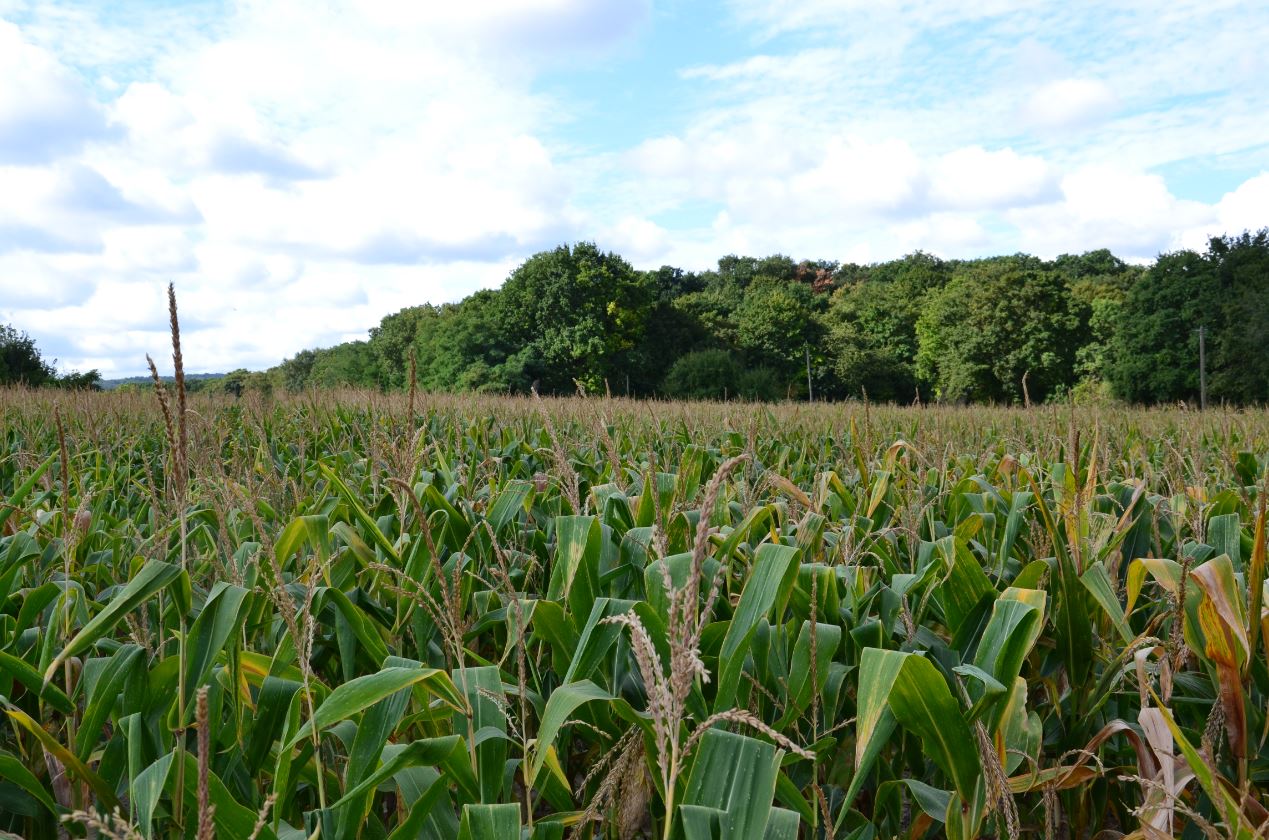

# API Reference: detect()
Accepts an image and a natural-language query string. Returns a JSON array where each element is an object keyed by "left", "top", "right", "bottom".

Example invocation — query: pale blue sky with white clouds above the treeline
[{"left": 0, "top": 0, "right": 1269, "bottom": 378}]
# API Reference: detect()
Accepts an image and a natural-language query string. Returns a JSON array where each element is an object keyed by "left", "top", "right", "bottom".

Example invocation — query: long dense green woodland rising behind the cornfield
[{"left": 22, "top": 228, "right": 1269, "bottom": 405}]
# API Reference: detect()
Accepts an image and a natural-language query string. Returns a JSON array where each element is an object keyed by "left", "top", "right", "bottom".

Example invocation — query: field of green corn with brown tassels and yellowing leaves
[{"left": 0, "top": 378, "right": 1269, "bottom": 840}]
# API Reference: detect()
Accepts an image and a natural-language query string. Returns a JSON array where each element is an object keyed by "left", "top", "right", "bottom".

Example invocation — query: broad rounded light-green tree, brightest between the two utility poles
[{"left": 916, "top": 256, "right": 1079, "bottom": 402}]
